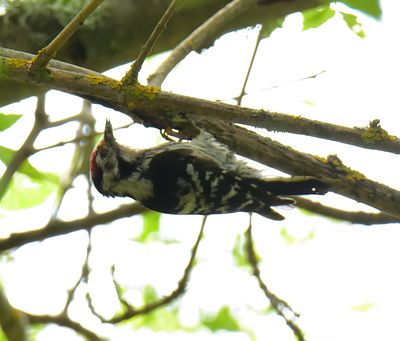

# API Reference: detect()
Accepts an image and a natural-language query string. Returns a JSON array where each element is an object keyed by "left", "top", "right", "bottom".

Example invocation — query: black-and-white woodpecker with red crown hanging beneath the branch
[{"left": 90, "top": 121, "right": 327, "bottom": 220}]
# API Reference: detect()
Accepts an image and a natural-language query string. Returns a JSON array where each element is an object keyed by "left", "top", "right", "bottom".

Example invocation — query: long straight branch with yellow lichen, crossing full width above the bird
[{"left": 0, "top": 50, "right": 400, "bottom": 154}]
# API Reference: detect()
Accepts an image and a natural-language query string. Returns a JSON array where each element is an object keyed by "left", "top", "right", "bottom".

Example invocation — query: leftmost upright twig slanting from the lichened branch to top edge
[{"left": 30, "top": 0, "right": 104, "bottom": 72}]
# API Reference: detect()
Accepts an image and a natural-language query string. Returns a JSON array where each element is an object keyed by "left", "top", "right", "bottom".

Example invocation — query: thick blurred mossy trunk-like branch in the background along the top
[{"left": 0, "top": 0, "right": 329, "bottom": 105}]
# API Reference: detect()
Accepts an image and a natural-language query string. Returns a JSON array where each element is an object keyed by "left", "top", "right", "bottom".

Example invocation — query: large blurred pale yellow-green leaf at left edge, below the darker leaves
[{"left": 0, "top": 173, "right": 57, "bottom": 210}]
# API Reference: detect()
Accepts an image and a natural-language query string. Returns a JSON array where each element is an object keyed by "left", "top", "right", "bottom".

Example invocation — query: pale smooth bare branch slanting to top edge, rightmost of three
[{"left": 148, "top": 0, "right": 256, "bottom": 87}]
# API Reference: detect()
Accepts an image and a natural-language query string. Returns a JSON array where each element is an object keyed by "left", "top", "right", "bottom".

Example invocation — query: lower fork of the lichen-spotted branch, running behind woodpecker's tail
[{"left": 196, "top": 120, "right": 400, "bottom": 217}]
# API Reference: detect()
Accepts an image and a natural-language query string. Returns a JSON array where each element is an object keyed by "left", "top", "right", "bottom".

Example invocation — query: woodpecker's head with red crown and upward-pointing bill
[{"left": 90, "top": 120, "right": 120, "bottom": 196}]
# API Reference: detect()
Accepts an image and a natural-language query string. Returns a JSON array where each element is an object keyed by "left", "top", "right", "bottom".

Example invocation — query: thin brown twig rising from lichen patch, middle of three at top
[{"left": 122, "top": 0, "right": 184, "bottom": 85}]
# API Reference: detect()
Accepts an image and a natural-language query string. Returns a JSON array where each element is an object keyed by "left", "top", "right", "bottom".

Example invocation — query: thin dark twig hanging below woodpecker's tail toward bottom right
[{"left": 246, "top": 216, "right": 305, "bottom": 341}]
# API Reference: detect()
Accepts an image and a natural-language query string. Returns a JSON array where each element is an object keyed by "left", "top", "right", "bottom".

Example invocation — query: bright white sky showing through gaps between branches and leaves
[{"left": 0, "top": 0, "right": 400, "bottom": 341}]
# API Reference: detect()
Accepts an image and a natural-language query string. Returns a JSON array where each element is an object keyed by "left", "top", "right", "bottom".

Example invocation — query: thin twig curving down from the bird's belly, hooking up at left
[{"left": 88, "top": 216, "right": 207, "bottom": 324}]
